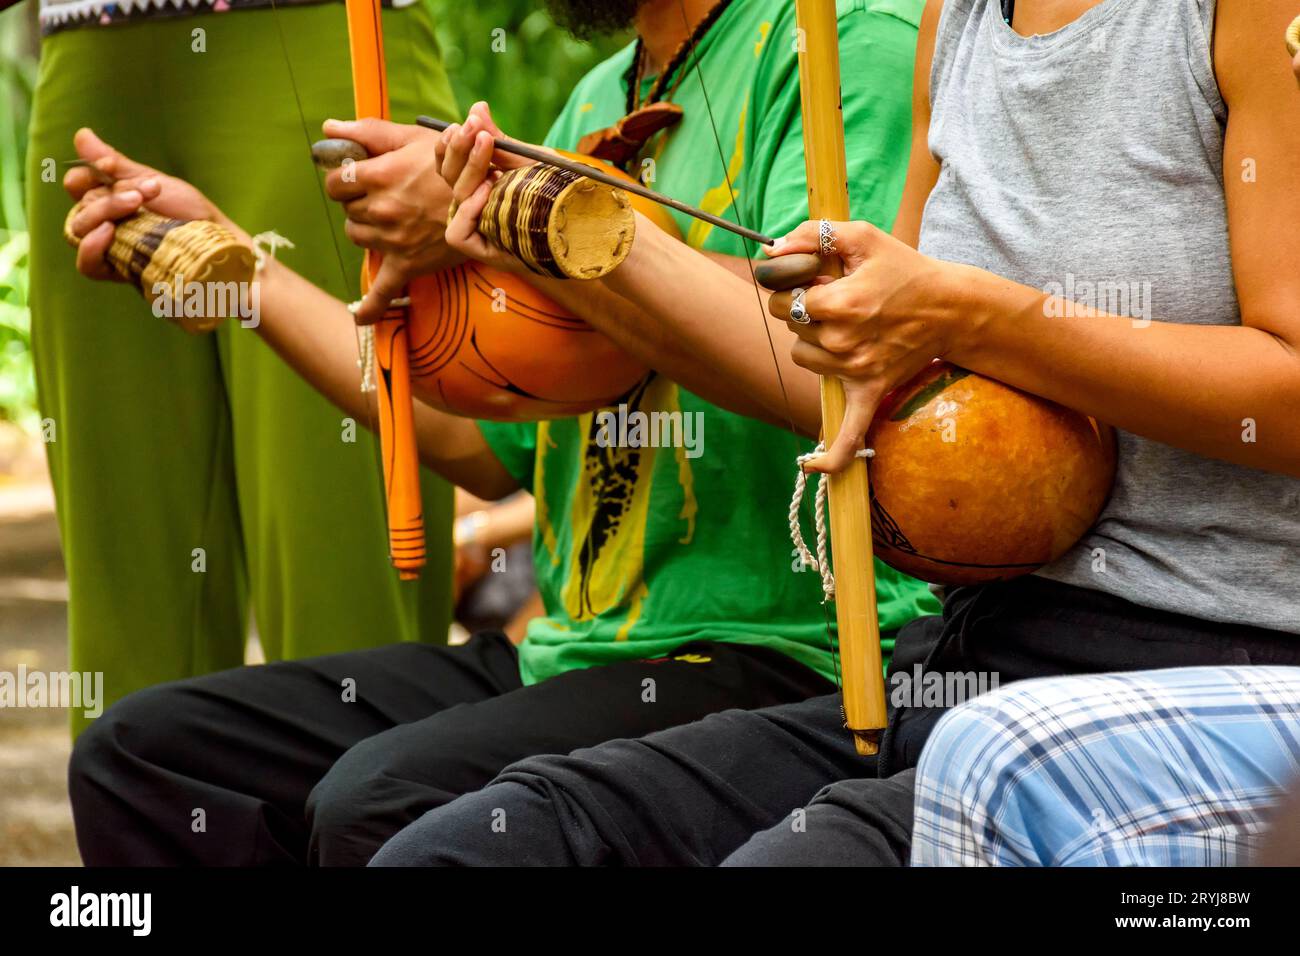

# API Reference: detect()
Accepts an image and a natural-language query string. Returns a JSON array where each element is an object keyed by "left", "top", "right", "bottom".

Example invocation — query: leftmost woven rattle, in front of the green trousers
[{"left": 64, "top": 206, "right": 256, "bottom": 334}]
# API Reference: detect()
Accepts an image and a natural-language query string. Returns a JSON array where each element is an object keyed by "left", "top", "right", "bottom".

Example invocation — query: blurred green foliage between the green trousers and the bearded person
[{"left": 426, "top": 0, "right": 629, "bottom": 143}]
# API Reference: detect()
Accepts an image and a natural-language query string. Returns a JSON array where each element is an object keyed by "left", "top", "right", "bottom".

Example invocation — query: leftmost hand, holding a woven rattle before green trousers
[{"left": 64, "top": 129, "right": 236, "bottom": 280}]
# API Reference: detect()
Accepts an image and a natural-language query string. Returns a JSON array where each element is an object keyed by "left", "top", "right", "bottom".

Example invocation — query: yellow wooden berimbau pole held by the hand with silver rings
[{"left": 794, "top": 0, "right": 888, "bottom": 756}]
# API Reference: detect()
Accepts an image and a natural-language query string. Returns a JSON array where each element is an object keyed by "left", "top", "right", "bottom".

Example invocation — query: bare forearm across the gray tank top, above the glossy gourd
[{"left": 945, "top": 267, "right": 1300, "bottom": 475}]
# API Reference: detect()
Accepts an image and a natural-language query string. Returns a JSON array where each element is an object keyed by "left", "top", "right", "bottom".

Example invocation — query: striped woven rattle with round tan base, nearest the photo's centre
[{"left": 478, "top": 164, "right": 636, "bottom": 278}]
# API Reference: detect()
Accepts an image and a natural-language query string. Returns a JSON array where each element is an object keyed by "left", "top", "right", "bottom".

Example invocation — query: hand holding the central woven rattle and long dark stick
[{"left": 437, "top": 103, "right": 532, "bottom": 273}]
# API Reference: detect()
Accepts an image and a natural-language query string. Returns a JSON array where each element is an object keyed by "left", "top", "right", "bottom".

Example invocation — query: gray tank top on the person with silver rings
[{"left": 920, "top": 0, "right": 1300, "bottom": 633}]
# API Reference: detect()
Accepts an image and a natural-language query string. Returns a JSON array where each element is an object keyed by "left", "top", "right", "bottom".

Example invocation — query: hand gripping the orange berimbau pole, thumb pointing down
[{"left": 324, "top": 120, "right": 463, "bottom": 325}]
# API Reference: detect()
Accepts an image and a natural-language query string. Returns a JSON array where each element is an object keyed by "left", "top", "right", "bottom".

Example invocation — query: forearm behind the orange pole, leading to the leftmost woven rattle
[{"left": 244, "top": 260, "right": 519, "bottom": 499}]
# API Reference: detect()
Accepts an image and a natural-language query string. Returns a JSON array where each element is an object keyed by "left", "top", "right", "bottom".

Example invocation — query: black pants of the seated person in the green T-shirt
[{"left": 69, "top": 633, "right": 831, "bottom": 865}]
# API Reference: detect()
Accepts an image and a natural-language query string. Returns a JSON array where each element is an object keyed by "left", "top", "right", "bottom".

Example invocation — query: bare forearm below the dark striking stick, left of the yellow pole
[{"left": 538, "top": 221, "right": 820, "bottom": 434}]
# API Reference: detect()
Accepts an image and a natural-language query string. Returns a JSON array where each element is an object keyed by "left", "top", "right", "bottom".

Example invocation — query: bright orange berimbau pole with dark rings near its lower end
[{"left": 346, "top": 0, "right": 425, "bottom": 580}]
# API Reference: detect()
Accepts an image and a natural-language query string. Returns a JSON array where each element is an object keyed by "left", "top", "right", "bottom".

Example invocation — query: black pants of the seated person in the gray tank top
[{"left": 372, "top": 578, "right": 1300, "bottom": 866}]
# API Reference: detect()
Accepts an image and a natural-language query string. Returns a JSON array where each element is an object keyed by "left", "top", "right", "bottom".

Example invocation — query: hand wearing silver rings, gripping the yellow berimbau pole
[{"left": 766, "top": 222, "right": 972, "bottom": 472}]
